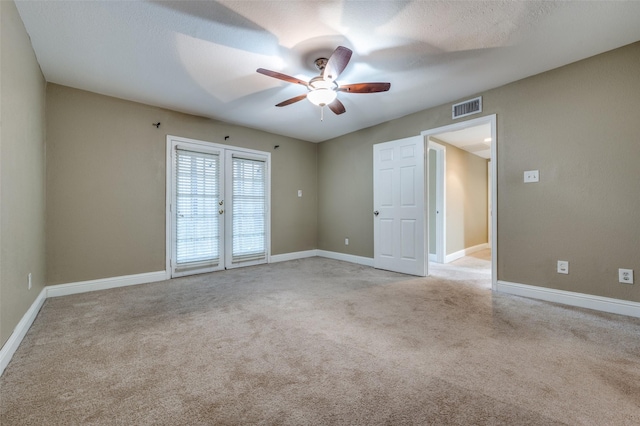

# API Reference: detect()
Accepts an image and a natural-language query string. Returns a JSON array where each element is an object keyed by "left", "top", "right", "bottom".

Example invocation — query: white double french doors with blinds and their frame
[{"left": 167, "top": 136, "right": 270, "bottom": 277}]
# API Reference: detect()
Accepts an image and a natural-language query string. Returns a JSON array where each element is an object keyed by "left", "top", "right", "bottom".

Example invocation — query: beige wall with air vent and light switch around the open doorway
[{"left": 318, "top": 42, "right": 640, "bottom": 301}]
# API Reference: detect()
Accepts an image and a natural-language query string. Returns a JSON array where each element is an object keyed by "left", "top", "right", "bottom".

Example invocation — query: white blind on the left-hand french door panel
[{"left": 175, "top": 149, "right": 220, "bottom": 267}]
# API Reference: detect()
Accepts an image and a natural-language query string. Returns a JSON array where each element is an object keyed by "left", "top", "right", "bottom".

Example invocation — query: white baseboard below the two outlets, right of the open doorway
[{"left": 496, "top": 281, "right": 640, "bottom": 318}]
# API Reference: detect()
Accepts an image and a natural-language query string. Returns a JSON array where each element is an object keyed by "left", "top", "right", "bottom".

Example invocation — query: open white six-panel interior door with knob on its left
[{"left": 373, "top": 136, "right": 428, "bottom": 277}]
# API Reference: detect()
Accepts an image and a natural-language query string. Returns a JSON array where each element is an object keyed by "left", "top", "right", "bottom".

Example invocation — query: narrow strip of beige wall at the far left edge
[{"left": 0, "top": 1, "right": 45, "bottom": 346}]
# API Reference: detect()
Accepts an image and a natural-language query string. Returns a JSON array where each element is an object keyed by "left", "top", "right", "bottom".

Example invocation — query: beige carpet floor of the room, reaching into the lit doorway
[{"left": 0, "top": 256, "right": 640, "bottom": 426}]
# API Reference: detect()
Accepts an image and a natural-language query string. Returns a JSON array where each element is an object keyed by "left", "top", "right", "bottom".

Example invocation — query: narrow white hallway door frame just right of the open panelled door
[{"left": 425, "top": 137, "right": 447, "bottom": 263}]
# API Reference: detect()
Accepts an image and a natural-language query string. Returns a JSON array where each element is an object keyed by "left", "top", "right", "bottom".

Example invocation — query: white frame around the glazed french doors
[{"left": 165, "top": 135, "right": 271, "bottom": 278}]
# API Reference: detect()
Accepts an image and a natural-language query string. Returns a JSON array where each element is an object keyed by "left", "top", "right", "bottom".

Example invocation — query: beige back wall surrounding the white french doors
[{"left": 46, "top": 84, "right": 317, "bottom": 285}]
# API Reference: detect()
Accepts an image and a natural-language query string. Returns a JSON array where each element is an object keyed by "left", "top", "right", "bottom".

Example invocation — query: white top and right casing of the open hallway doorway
[{"left": 420, "top": 114, "right": 498, "bottom": 291}]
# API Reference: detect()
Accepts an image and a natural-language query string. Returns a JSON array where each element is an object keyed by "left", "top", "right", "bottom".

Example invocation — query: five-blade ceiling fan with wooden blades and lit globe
[{"left": 256, "top": 46, "right": 391, "bottom": 119}]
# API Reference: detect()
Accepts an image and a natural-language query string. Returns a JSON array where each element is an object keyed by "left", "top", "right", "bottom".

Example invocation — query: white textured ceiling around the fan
[{"left": 16, "top": 0, "right": 640, "bottom": 142}]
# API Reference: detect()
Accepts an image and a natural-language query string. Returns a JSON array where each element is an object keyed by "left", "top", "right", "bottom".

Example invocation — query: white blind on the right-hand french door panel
[{"left": 231, "top": 157, "right": 267, "bottom": 263}]
